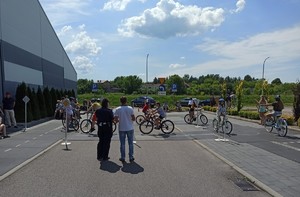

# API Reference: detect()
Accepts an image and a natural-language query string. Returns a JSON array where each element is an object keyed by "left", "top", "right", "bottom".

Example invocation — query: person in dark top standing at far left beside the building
[{"left": 2, "top": 92, "right": 18, "bottom": 128}]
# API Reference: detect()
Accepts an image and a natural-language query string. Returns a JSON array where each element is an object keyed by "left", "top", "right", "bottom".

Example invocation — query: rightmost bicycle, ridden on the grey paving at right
[{"left": 265, "top": 115, "right": 288, "bottom": 137}]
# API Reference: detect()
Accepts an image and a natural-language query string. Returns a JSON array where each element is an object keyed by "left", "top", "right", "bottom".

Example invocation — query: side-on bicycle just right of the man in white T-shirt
[{"left": 139, "top": 119, "right": 174, "bottom": 134}]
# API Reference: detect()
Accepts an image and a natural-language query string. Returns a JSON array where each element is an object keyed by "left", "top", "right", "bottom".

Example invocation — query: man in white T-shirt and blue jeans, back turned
[{"left": 114, "top": 96, "right": 135, "bottom": 162}]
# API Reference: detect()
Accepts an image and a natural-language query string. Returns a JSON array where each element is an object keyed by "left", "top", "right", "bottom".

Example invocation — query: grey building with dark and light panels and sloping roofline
[{"left": 0, "top": 0, "right": 77, "bottom": 101}]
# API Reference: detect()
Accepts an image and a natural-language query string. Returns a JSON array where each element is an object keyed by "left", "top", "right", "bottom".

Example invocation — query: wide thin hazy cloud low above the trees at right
[{"left": 168, "top": 25, "right": 300, "bottom": 81}]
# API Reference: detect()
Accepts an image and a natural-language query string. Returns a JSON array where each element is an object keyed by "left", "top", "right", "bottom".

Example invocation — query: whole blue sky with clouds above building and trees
[{"left": 40, "top": 0, "right": 300, "bottom": 82}]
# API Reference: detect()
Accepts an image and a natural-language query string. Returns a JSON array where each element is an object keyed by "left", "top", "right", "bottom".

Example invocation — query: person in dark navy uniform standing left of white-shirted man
[{"left": 95, "top": 98, "right": 114, "bottom": 161}]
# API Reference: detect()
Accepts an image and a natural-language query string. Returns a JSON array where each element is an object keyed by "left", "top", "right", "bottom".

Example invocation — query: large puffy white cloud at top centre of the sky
[{"left": 118, "top": 0, "right": 224, "bottom": 39}]
